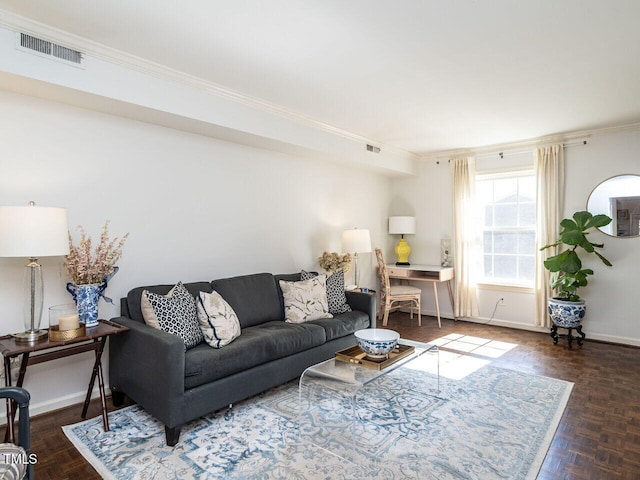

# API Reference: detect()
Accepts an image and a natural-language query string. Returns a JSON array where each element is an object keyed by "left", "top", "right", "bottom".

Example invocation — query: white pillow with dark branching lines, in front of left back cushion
[{"left": 198, "top": 291, "right": 241, "bottom": 348}]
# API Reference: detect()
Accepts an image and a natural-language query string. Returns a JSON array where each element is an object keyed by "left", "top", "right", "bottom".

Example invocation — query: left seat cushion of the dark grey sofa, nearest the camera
[{"left": 185, "top": 320, "right": 326, "bottom": 388}]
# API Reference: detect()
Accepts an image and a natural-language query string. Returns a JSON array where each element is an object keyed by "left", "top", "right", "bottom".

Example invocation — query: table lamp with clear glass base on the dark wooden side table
[{"left": 0, "top": 202, "right": 69, "bottom": 343}]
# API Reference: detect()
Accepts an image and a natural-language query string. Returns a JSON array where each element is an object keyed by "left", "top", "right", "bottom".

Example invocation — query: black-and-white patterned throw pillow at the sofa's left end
[{"left": 142, "top": 282, "right": 204, "bottom": 348}]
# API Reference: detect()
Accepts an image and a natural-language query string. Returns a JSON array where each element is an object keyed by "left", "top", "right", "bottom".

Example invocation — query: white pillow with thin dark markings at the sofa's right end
[{"left": 280, "top": 273, "right": 333, "bottom": 323}]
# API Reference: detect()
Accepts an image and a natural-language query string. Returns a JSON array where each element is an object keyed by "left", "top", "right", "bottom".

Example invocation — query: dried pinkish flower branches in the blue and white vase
[{"left": 64, "top": 220, "right": 129, "bottom": 285}]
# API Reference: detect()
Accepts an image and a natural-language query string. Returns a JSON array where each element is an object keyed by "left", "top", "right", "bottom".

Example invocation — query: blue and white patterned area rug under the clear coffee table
[{"left": 64, "top": 365, "right": 573, "bottom": 480}]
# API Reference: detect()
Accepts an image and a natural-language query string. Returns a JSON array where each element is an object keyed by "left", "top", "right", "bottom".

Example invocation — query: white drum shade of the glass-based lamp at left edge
[{"left": 0, "top": 205, "right": 69, "bottom": 258}]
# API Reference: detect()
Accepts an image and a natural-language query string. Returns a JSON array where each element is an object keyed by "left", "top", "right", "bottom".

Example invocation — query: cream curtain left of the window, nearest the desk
[{"left": 451, "top": 157, "right": 479, "bottom": 317}]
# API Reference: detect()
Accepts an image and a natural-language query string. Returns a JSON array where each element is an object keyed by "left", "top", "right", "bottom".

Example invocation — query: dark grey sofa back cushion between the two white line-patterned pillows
[{"left": 211, "top": 273, "right": 283, "bottom": 328}]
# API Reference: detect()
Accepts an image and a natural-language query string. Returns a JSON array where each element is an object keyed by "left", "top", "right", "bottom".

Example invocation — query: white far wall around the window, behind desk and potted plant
[{"left": 387, "top": 130, "right": 640, "bottom": 345}]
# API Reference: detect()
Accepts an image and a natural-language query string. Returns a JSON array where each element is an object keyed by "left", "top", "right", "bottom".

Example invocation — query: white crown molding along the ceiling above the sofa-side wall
[{"left": 0, "top": 9, "right": 420, "bottom": 160}]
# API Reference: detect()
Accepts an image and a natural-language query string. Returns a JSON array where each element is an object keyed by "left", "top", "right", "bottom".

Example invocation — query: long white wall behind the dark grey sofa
[{"left": 0, "top": 90, "right": 390, "bottom": 413}]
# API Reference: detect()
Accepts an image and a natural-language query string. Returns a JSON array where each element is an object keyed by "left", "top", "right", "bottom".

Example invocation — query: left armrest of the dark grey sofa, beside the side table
[{"left": 109, "top": 317, "right": 185, "bottom": 426}]
